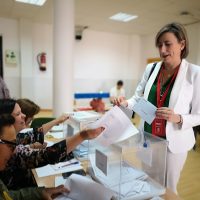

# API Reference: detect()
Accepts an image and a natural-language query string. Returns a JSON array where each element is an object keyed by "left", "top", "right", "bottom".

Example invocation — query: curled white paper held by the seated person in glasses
[{"left": 56, "top": 174, "right": 115, "bottom": 200}]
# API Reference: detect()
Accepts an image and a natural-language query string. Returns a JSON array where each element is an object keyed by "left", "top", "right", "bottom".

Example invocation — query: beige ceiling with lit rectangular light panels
[{"left": 0, "top": 0, "right": 200, "bottom": 35}]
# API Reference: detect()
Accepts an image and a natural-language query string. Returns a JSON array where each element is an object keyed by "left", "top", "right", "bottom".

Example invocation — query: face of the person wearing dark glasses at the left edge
[{"left": 0, "top": 125, "right": 16, "bottom": 171}]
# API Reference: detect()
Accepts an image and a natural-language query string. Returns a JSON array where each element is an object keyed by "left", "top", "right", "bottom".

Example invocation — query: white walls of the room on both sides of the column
[{"left": 0, "top": 18, "right": 200, "bottom": 109}]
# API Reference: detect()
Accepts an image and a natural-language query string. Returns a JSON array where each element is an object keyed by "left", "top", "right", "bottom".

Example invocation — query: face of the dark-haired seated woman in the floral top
[{"left": 11, "top": 103, "right": 26, "bottom": 133}]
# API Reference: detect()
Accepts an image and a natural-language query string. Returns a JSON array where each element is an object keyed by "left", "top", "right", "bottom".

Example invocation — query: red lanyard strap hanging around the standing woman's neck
[{"left": 156, "top": 65, "right": 180, "bottom": 108}]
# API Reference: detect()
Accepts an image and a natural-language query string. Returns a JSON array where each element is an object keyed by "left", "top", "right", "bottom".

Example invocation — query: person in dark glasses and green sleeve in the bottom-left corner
[{"left": 0, "top": 115, "right": 69, "bottom": 200}]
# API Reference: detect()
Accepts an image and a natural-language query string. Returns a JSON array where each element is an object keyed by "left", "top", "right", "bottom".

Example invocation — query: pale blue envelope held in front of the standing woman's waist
[{"left": 133, "top": 98, "right": 157, "bottom": 124}]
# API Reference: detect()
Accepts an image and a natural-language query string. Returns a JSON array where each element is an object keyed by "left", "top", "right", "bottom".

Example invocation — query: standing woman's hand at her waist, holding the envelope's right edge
[{"left": 156, "top": 107, "right": 180, "bottom": 123}]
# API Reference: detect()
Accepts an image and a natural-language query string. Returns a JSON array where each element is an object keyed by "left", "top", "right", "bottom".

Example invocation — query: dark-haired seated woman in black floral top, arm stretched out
[{"left": 0, "top": 99, "right": 103, "bottom": 189}]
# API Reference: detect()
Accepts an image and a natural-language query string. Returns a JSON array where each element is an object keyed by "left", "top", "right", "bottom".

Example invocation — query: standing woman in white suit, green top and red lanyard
[{"left": 115, "top": 23, "right": 200, "bottom": 193}]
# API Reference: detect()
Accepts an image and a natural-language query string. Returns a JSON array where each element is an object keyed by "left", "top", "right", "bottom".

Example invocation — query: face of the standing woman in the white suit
[{"left": 158, "top": 32, "right": 185, "bottom": 67}]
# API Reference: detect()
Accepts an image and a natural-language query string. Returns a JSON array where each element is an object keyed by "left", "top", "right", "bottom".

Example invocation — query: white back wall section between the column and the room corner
[{"left": 74, "top": 30, "right": 140, "bottom": 99}]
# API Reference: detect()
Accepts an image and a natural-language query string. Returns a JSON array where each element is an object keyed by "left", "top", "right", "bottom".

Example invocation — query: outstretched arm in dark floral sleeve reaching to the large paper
[{"left": 13, "top": 127, "right": 104, "bottom": 169}]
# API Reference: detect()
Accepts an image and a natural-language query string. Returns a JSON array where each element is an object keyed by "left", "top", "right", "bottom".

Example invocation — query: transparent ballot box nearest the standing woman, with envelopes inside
[{"left": 88, "top": 133, "right": 167, "bottom": 200}]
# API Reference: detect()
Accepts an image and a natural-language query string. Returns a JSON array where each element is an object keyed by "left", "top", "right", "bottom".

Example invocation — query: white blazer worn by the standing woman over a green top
[{"left": 128, "top": 59, "right": 200, "bottom": 153}]
